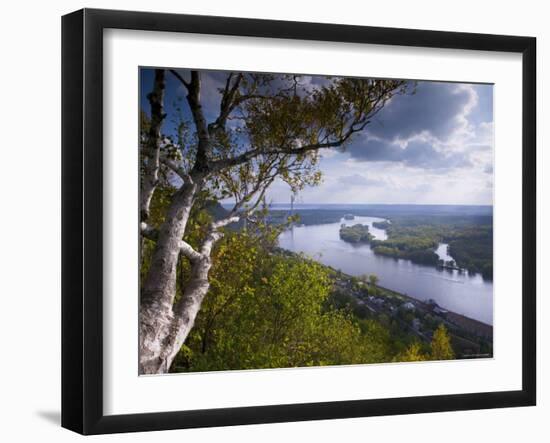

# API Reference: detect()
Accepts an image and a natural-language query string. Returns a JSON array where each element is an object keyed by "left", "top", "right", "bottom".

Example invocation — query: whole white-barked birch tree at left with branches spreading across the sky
[{"left": 139, "top": 69, "right": 409, "bottom": 374}]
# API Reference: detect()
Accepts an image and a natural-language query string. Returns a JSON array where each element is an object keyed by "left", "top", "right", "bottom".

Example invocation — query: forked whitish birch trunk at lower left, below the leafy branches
[{"left": 139, "top": 175, "right": 239, "bottom": 374}]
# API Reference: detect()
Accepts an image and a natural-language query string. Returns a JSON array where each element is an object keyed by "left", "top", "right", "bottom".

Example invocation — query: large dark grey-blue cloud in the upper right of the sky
[{"left": 349, "top": 82, "right": 493, "bottom": 171}]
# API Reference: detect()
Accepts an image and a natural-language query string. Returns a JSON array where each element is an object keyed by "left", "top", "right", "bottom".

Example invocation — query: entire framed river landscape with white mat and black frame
[{"left": 62, "top": 9, "right": 536, "bottom": 434}]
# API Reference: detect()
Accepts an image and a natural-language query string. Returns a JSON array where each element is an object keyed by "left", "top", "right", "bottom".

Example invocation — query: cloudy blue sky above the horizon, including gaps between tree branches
[{"left": 140, "top": 69, "right": 494, "bottom": 205}]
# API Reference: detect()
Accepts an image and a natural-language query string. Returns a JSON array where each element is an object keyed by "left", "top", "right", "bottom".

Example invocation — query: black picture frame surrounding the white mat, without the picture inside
[{"left": 62, "top": 9, "right": 536, "bottom": 434}]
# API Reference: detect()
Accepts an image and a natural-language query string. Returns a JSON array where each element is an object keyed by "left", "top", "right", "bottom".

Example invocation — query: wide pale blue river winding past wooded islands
[{"left": 279, "top": 217, "right": 493, "bottom": 325}]
